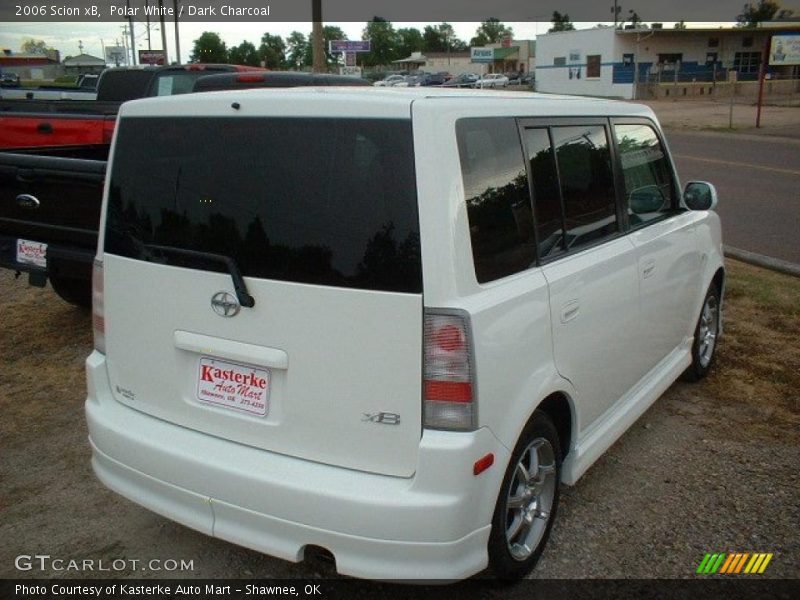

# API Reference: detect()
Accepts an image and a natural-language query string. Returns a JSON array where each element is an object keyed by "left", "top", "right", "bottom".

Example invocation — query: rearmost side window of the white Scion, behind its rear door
[{"left": 456, "top": 118, "right": 536, "bottom": 283}]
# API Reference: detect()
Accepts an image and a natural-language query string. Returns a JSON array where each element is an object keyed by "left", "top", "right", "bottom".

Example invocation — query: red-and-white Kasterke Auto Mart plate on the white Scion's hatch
[{"left": 197, "top": 357, "right": 269, "bottom": 417}]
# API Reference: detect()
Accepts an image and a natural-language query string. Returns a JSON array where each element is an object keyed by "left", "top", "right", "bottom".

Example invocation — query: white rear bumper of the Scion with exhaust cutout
[{"left": 86, "top": 353, "right": 509, "bottom": 580}]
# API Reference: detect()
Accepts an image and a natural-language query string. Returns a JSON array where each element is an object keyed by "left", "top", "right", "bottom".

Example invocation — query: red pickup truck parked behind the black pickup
[{"left": 0, "top": 64, "right": 264, "bottom": 149}]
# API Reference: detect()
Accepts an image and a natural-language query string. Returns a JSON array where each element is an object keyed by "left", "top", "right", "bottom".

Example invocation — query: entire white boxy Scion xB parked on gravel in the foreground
[{"left": 86, "top": 88, "right": 724, "bottom": 580}]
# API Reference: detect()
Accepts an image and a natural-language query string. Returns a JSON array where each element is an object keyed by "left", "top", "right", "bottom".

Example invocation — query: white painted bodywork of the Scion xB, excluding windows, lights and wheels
[{"left": 86, "top": 88, "right": 723, "bottom": 579}]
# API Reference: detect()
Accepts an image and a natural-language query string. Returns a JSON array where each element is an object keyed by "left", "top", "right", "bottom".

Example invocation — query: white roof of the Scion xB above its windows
[{"left": 120, "top": 86, "right": 652, "bottom": 118}]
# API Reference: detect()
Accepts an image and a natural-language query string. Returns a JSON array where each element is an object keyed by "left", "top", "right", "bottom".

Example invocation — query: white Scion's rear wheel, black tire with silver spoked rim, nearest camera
[{"left": 488, "top": 410, "right": 562, "bottom": 581}]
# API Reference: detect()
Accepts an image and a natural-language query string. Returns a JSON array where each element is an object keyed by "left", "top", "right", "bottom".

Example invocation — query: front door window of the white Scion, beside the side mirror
[{"left": 614, "top": 124, "right": 676, "bottom": 228}]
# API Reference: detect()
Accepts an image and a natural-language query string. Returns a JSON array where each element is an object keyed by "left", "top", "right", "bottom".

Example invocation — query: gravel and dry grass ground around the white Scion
[{"left": 0, "top": 262, "right": 800, "bottom": 584}]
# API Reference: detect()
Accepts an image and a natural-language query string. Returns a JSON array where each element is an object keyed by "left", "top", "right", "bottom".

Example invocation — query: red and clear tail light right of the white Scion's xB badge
[{"left": 423, "top": 309, "right": 478, "bottom": 431}]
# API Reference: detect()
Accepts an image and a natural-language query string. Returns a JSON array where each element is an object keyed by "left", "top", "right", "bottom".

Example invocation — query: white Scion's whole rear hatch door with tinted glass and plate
[{"left": 104, "top": 94, "right": 422, "bottom": 476}]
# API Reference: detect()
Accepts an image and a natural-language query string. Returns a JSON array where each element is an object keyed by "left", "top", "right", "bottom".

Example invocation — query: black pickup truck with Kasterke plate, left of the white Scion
[{"left": 0, "top": 71, "right": 368, "bottom": 308}]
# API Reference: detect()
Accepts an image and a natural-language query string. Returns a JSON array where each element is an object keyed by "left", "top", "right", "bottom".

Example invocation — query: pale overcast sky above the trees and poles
[{"left": 0, "top": 20, "right": 730, "bottom": 62}]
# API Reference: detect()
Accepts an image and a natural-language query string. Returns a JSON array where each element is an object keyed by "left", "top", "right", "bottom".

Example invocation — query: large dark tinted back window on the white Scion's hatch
[{"left": 105, "top": 118, "right": 422, "bottom": 293}]
